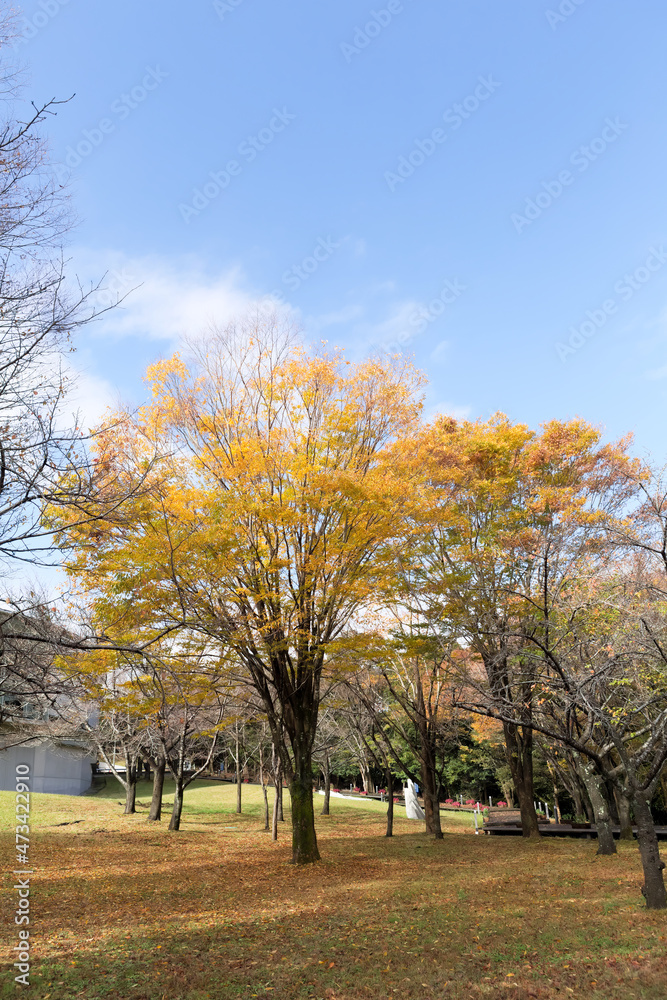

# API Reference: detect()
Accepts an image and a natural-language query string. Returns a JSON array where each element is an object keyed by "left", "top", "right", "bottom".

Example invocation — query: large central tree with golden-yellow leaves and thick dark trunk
[{"left": 54, "top": 315, "right": 423, "bottom": 863}]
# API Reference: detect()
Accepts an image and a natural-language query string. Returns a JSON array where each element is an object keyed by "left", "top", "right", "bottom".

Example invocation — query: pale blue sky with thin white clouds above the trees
[{"left": 11, "top": 0, "right": 667, "bottom": 461}]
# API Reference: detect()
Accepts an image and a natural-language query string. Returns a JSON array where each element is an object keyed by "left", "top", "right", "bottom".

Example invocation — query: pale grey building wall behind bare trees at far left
[{"left": 0, "top": 744, "right": 95, "bottom": 795}]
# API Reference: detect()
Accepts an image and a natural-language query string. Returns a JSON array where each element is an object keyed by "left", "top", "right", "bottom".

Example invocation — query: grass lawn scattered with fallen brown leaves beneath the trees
[{"left": 0, "top": 779, "right": 667, "bottom": 1000}]
